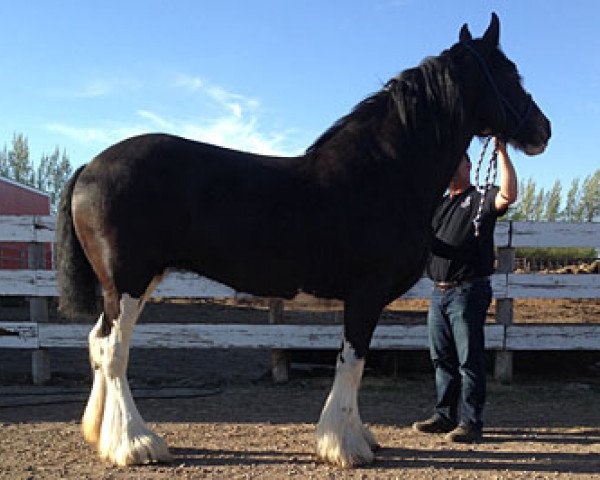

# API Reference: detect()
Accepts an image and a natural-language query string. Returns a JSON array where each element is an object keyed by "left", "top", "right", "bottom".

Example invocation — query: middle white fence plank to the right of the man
[{"left": 507, "top": 273, "right": 600, "bottom": 298}]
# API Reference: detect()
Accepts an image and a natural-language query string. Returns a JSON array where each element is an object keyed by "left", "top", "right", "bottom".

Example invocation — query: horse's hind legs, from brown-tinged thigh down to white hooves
[{"left": 71, "top": 185, "right": 171, "bottom": 465}]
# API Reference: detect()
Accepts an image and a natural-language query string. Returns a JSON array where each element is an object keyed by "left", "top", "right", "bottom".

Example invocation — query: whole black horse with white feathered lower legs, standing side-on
[{"left": 57, "top": 14, "right": 550, "bottom": 467}]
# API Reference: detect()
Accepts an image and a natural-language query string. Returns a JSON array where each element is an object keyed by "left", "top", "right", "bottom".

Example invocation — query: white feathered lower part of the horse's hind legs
[{"left": 84, "top": 295, "right": 171, "bottom": 466}]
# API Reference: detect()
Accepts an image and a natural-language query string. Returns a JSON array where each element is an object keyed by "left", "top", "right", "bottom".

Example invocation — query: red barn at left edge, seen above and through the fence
[{"left": 0, "top": 177, "right": 52, "bottom": 269}]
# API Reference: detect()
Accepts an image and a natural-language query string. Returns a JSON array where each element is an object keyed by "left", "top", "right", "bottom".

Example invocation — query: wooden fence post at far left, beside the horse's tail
[{"left": 27, "top": 243, "right": 50, "bottom": 385}]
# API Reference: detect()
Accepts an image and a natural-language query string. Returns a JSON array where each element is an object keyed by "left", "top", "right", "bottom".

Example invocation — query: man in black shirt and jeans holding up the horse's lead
[{"left": 413, "top": 138, "right": 517, "bottom": 443}]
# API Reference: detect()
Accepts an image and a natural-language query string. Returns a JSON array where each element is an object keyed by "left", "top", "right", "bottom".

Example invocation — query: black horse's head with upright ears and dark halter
[{"left": 452, "top": 13, "right": 550, "bottom": 155}]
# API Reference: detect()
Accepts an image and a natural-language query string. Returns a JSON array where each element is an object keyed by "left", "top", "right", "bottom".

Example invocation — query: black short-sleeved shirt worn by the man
[{"left": 427, "top": 186, "right": 506, "bottom": 282}]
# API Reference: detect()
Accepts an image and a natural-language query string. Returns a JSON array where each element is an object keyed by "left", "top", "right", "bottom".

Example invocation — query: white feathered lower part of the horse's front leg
[{"left": 317, "top": 340, "right": 377, "bottom": 468}]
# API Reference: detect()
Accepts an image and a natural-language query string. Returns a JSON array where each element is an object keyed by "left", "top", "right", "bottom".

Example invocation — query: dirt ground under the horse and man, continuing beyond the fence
[{"left": 0, "top": 301, "right": 600, "bottom": 480}]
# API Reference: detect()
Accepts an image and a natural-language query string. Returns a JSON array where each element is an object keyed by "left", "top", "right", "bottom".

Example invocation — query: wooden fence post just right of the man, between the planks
[{"left": 494, "top": 246, "right": 515, "bottom": 384}]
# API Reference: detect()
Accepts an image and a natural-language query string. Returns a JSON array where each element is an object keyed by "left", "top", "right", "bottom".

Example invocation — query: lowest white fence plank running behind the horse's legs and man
[{"left": 39, "top": 323, "right": 504, "bottom": 350}]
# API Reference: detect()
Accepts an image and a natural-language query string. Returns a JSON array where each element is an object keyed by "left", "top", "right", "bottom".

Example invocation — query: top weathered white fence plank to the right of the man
[{"left": 508, "top": 222, "right": 600, "bottom": 248}]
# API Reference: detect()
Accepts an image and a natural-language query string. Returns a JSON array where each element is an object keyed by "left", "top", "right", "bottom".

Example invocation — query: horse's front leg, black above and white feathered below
[{"left": 317, "top": 296, "right": 381, "bottom": 468}]
